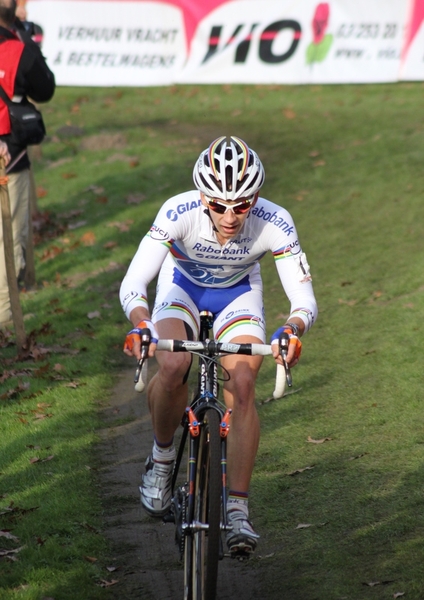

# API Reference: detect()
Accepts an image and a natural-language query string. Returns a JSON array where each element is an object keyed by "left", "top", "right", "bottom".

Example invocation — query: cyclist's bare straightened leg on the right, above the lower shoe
[{"left": 221, "top": 336, "right": 262, "bottom": 492}]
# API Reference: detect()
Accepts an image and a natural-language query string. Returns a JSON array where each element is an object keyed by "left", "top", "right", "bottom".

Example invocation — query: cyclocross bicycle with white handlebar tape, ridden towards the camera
[{"left": 134, "top": 311, "right": 292, "bottom": 600}]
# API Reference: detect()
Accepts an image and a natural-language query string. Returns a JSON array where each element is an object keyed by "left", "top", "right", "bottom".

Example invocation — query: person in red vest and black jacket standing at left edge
[{"left": 0, "top": 0, "right": 55, "bottom": 325}]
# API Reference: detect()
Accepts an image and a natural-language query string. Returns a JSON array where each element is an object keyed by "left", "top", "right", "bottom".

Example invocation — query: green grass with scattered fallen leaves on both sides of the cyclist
[{"left": 0, "top": 83, "right": 424, "bottom": 600}]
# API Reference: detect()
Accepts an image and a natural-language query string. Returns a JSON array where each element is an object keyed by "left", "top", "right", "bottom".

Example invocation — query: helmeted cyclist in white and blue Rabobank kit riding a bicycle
[{"left": 120, "top": 137, "right": 317, "bottom": 553}]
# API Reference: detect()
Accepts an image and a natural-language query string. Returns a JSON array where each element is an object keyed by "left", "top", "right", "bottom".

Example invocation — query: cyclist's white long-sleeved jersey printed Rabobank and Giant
[{"left": 120, "top": 190, "right": 317, "bottom": 331}]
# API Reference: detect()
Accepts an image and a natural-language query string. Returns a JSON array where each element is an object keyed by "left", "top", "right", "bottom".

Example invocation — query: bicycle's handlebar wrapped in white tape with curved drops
[{"left": 134, "top": 340, "right": 292, "bottom": 399}]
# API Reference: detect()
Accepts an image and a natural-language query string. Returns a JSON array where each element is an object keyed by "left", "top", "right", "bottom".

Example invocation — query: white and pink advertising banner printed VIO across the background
[{"left": 27, "top": 0, "right": 424, "bottom": 86}]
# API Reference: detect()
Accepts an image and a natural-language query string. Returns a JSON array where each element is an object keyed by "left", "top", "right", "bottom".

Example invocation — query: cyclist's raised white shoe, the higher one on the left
[{"left": 139, "top": 456, "right": 174, "bottom": 517}]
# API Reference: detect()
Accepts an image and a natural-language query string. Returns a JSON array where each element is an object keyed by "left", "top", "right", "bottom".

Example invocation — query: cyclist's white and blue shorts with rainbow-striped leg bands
[{"left": 152, "top": 264, "right": 266, "bottom": 343}]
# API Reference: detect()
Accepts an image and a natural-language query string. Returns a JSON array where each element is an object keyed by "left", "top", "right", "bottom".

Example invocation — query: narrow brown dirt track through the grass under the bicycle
[{"left": 100, "top": 369, "right": 265, "bottom": 600}]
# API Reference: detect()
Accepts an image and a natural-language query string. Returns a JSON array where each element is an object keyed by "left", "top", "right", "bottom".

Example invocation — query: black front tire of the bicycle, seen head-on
[{"left": 185, "top": 409, "right": 221, "bottom": 600}]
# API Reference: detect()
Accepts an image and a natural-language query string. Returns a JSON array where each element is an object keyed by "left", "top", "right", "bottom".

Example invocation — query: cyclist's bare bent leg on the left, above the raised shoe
[{"left": 147, "top": 319, "right": 190, "bottom": 444}]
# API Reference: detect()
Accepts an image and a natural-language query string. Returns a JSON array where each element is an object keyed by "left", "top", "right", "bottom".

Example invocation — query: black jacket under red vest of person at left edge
[{"left": 0, "top": 26, "right": 56, "bottom": 173}]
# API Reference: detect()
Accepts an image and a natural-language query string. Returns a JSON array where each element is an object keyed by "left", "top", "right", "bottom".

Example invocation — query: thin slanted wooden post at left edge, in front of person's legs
[{"left": 0, "top": 157, "right": 26, "bottom": 354}]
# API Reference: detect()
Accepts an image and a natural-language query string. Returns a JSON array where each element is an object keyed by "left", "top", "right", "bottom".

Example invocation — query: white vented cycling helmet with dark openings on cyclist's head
[{"left": 193, "top": 136, "right": 265, "bottom": 202}]
